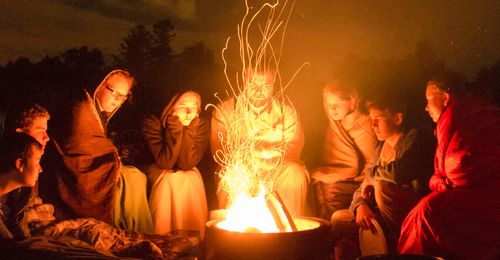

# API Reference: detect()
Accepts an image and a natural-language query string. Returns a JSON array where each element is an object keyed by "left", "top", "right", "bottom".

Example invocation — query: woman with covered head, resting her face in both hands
[{"left": 143, "top": 91, "right": 210, "bottom": 237}]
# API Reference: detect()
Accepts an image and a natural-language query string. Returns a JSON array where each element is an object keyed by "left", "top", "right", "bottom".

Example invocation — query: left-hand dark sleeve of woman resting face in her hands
[{"left": 142, "top": 115, "right": 182, "bottom": 169}]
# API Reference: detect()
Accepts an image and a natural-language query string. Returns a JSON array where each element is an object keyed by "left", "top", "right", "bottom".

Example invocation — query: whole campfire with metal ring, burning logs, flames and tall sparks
[{"left": 206, "top": 0, "right": 329, "bottom": 259}]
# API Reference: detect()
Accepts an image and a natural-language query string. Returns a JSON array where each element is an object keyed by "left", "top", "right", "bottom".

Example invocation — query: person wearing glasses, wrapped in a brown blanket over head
[{"left": 39, "top": 70, "right": 153, "bottom": 232}]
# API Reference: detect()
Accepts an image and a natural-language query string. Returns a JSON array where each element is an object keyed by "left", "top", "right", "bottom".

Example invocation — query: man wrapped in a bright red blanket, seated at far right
[{"left": 398, "top": 73, "right": 500, "bottom": 259}]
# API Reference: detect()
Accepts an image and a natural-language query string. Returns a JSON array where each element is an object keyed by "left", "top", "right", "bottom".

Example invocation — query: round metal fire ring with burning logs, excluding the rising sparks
[{"left": 205, "top": 193, "right": 331, "bottom": 260}]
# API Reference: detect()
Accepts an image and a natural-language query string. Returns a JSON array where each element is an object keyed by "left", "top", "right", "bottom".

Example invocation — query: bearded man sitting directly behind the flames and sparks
[{"left": 210, "top": 68, "right": 309, "bottom": 216}]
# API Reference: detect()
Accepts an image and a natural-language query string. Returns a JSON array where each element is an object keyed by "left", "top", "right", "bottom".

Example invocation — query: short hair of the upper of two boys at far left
[{"left": 5, "top": 103, "right": 50, "bottom": 132}]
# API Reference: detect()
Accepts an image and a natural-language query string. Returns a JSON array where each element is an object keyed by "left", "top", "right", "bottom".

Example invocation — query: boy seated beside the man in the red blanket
[{"left": 331, "top": 92, "right": 434, "bottom": 253}]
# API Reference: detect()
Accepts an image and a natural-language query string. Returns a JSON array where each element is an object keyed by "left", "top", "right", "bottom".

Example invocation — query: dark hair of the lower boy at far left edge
[{"left": 0, "top": 132, "right": 43, "bottom": 173}]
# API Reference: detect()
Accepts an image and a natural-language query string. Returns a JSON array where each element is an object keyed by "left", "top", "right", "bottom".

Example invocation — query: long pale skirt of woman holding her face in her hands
[{"left": 149, "top": 167, "right": 208, "bottom": 238}]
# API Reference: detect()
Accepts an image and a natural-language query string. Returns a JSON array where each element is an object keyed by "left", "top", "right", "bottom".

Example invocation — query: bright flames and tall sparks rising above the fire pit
[{"left": 209, "top": 0, "right": 306, "bottom": 232}]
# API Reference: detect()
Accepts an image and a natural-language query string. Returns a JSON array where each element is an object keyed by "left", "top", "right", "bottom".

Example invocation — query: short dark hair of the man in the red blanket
[{"left": 427, "top": 72, "right": 468, "bottom": 95}]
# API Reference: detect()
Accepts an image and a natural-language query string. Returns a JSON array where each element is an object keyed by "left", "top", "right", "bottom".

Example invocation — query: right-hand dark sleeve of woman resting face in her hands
[{"left": 177, "top": 117, "right": 210, "bottom": 170}]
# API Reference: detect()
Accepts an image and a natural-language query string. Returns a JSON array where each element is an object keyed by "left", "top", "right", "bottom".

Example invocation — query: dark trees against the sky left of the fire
[{"left": 0, "top": 19, "right": 223, "bottom": 133}]
